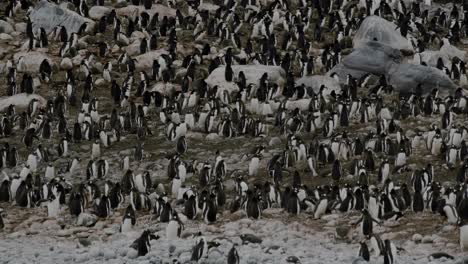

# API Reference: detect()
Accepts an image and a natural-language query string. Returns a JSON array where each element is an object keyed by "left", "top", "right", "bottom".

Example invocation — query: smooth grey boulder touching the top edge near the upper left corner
[{"left": 29, "top": 0, "right": 94, "bottom": 34}]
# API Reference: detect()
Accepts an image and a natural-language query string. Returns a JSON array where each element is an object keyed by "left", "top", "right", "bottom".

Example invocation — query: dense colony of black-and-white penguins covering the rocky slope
[{"left": 0, "top": 0, "right": 468, "bottom": 263}]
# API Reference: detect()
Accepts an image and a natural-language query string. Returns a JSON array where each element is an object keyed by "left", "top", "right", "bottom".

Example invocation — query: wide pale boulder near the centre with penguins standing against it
[{"left": 205, "top": 65, "right": 286, "bottom": 92}]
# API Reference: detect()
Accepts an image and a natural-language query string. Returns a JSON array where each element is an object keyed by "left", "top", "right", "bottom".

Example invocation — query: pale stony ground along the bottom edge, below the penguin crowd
[{"left": 0, "top": 206, "right": 463, "bottom": 264}]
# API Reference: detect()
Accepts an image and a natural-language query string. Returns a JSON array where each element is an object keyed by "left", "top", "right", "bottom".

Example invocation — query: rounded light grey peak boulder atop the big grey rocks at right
[{"left": 353, "top": 16, "right": 413, "bottom": 50}]
